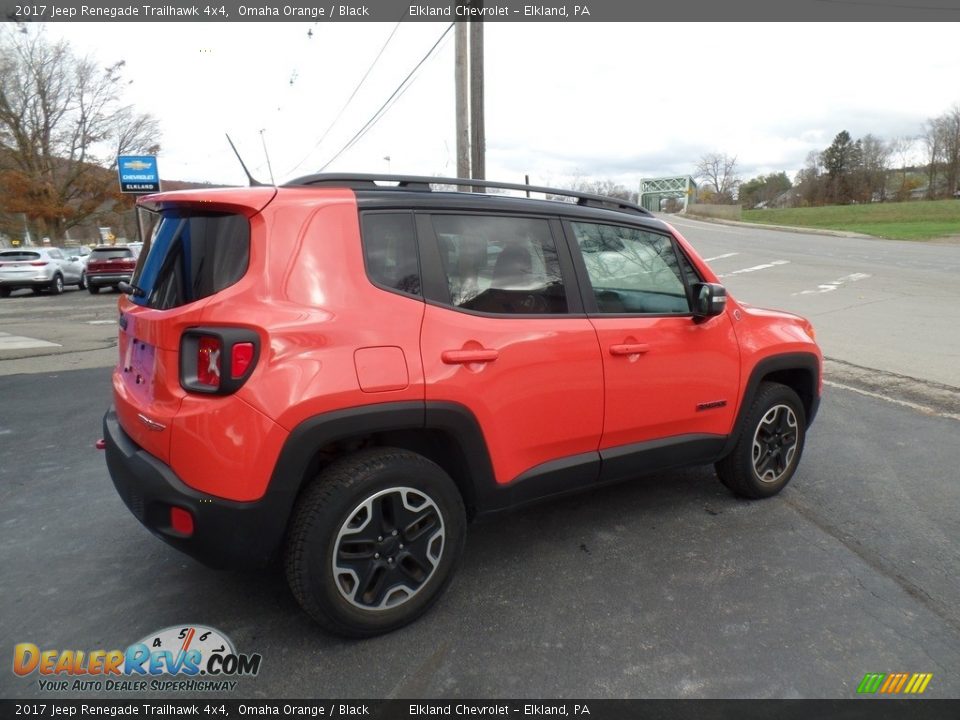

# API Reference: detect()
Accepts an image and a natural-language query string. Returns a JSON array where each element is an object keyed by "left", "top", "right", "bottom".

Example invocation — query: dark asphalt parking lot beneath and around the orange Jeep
[{"left": 0, "top": 225, "right": 960, "bottom": 698}]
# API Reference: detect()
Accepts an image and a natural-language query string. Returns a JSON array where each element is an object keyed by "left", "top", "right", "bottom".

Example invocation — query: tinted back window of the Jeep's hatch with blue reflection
[{"left": 132, "top": 209, "right": 250, "bottom": 310}]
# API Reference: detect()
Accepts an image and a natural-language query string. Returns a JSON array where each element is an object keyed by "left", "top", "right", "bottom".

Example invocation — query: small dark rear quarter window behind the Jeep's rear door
[{"left": 361, "top": 213, "right": 420, "bottom": 295}]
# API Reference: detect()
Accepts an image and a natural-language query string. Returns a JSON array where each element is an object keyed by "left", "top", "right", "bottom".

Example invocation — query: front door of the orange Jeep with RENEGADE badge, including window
[{"left": 564, "top": 221, "right": 740, "bottom": 474}]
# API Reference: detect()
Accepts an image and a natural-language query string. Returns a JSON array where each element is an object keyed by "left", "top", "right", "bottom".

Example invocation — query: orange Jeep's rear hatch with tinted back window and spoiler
[{"left": 115, "top": 188, "right": 275, "bottom": 462}]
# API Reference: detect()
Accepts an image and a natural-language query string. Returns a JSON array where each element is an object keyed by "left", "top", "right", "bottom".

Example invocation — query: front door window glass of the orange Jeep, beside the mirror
[{"left": 571, "top": 222, "right": 690, "bottom": 314}]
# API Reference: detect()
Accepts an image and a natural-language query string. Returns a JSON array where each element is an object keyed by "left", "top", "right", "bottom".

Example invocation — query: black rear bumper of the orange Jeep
[{"left": 103, "top": 408, "right": 292, "bottom": 568}]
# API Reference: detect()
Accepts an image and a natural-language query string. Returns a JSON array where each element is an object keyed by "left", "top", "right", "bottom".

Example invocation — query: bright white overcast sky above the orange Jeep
[{"left": 46, "top": 22, "right": 960, "bottom": 187}]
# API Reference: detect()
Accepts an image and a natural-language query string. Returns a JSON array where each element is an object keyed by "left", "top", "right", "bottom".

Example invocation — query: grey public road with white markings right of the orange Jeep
[{"left": 664, "top": 216, "right": 960, "bottom": 388}]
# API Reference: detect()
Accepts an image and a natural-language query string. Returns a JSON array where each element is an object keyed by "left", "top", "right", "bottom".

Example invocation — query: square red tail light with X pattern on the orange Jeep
[{"left": 180, "top": 328, "right": 260, "bottom": 395}]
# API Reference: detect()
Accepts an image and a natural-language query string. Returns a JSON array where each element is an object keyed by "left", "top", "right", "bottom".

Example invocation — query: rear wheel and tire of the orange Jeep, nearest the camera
[{"left": 285, "top": 448, "right": 466, "bottom": 637}]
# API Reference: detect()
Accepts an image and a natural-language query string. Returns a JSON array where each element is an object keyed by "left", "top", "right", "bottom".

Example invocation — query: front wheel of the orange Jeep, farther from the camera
[{"left": 716, "top": 382, "right": 807, "bottom": 498}]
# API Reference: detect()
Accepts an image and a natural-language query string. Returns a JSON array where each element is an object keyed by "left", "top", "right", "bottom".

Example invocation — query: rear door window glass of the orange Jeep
[{"left": 433, "top": 215, "right": 567, "bottom": 315}]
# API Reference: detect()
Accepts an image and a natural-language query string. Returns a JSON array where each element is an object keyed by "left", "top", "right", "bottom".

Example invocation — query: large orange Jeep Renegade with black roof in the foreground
[{"left": 105, "top": 175, "right": 822, "bottom": 636}]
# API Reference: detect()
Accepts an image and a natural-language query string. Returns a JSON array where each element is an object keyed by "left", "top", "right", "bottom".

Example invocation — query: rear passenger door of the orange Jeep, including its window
[{"left": 417, "top": 212, "right": 603, "bottom": 495}]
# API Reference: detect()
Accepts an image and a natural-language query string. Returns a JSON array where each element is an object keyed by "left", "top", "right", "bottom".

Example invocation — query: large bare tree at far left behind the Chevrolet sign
[{"left": 0, "top": 24, "right": 159, "bottom": 238}]
